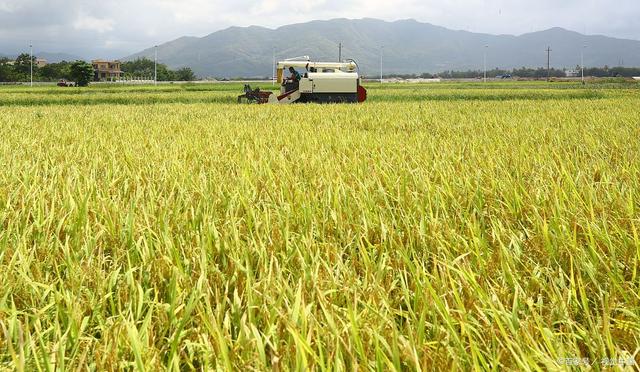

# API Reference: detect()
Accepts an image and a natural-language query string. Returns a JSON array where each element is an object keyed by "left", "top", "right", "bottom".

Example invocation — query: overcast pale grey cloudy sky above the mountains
[{"left": 0, "top": 0, "right": 640, "bottom": 58}]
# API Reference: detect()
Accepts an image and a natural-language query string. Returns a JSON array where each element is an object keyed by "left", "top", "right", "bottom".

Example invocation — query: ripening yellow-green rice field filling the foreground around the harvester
[{"left": 0, "top": 82, "right": 640, "bottom": 371}]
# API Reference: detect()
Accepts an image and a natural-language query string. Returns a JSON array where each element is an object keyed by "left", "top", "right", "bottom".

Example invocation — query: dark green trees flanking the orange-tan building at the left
[{"left": 0, "top": 53, "right": 196, "bottom": 85}]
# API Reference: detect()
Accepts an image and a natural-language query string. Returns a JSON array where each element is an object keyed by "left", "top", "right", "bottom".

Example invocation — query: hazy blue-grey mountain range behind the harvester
[{"left": 125, "top": 19, "right": 640, "bottom": 77}]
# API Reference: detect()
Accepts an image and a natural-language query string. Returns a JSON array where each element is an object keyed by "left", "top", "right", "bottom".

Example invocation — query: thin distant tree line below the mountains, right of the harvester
[{"left": 385, "top": 66, "right": 640, "bottom": 79}]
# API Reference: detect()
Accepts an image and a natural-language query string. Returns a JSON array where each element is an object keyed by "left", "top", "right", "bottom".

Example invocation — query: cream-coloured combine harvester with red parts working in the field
[{"left": 238, "top": 57, "right": 367, "bottom": 104}]
